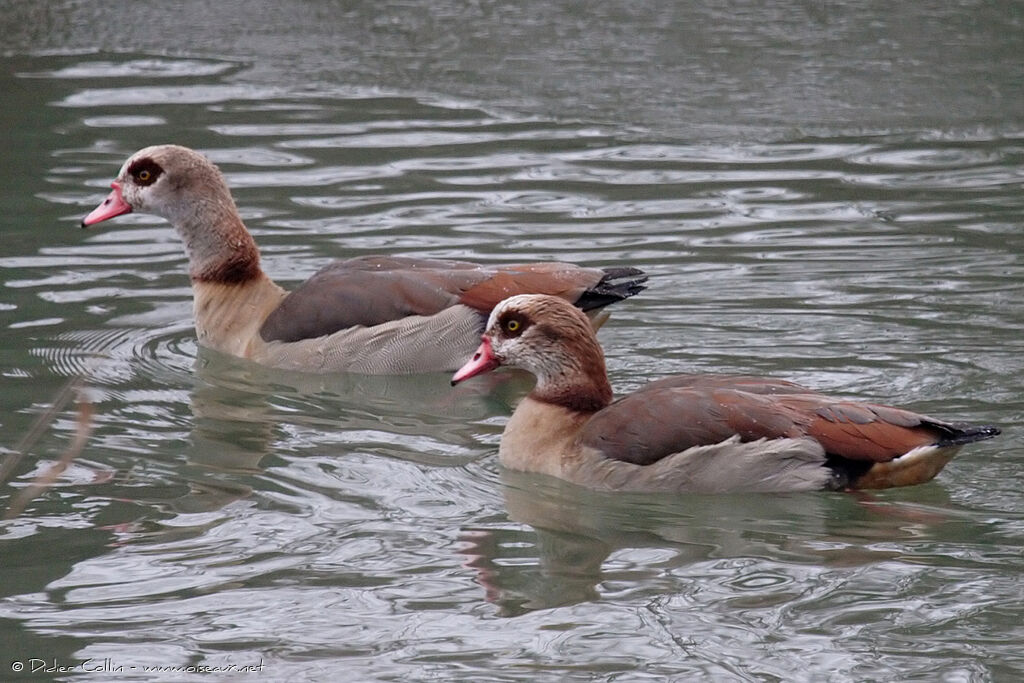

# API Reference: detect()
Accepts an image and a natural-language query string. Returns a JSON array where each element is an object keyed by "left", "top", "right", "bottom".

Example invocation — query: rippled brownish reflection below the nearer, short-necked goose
[{"left": 460, "top": 470, "right": 963, "bottom": 616}]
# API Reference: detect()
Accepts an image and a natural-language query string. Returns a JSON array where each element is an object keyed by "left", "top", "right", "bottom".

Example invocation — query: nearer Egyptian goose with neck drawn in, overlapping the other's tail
[{"left": 452, "top": 295, "right": 999, "bottom": 493}]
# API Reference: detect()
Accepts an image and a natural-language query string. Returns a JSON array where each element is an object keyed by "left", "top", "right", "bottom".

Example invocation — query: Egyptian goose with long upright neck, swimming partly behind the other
[{"left": 82, "top": 144, "right": 647, "bottom": 374}]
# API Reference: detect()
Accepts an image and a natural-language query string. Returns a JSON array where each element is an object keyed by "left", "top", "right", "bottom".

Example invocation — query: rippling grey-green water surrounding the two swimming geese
[{"left": 0, "top": 0, "right": 1024, "bottom": 681}]
